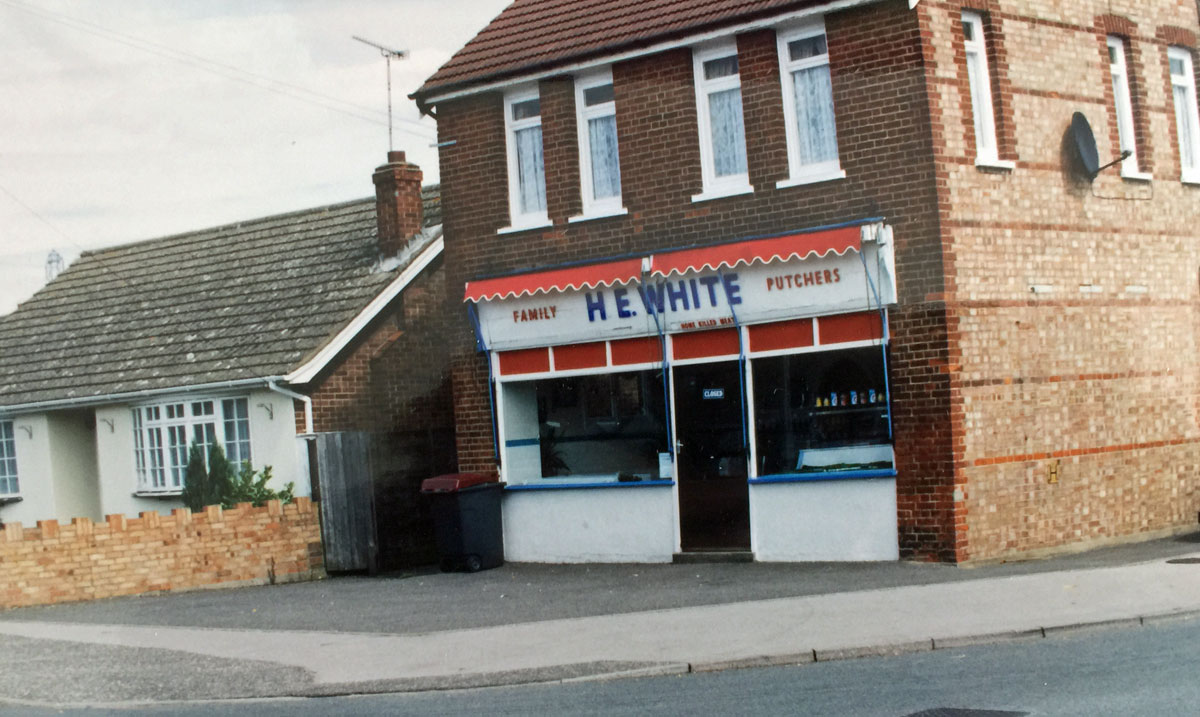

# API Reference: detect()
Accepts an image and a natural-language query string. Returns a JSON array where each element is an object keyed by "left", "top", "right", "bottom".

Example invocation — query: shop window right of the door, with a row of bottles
[{"left": 752, "top": 347, "right": 893, "bottom": 476}]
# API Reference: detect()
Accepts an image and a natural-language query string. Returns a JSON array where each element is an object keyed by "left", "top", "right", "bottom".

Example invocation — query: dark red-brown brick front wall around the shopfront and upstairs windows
[{"left": 438, "top": 0, "right": 959, "bottom": 560}]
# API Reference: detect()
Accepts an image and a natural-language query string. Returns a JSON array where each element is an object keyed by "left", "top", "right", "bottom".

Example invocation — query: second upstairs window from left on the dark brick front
[{"left": 575, "top": 70, "right": 623, "bottom": 217}]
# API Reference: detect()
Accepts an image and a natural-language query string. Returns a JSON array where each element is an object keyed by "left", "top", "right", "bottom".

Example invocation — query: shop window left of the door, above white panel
[{"left": 503, "top": 370, "right": 667, "bottom": 484}]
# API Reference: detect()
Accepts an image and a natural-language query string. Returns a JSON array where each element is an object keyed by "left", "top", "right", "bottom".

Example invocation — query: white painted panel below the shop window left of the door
[{"left": 503, "top": 486, "right": 681, "bottom": 562}]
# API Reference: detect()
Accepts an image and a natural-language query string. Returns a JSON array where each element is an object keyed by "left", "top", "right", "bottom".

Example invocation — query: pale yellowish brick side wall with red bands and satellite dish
[{"left": 916, "top": 0, "right": 1200, "bottom": 560}]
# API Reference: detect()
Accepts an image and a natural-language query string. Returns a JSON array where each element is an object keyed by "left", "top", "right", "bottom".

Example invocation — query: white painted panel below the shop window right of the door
[{"left": 750, "top": 478, "right": 900, "bottom": 562}]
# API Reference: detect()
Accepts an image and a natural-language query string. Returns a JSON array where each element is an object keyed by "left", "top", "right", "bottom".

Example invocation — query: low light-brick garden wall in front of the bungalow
[{"left": 0, "top": 498, "right": 324, "bottom": 608}]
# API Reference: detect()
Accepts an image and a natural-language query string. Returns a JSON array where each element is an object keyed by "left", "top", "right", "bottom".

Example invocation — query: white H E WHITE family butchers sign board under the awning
[{"left": 479, "top": 235, "right": 895, "bottom": 350}]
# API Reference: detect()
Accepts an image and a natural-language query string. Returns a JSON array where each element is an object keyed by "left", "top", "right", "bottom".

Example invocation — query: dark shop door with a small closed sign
[{"left": 674, "top": 361, "right": 750, "bottom": 550}]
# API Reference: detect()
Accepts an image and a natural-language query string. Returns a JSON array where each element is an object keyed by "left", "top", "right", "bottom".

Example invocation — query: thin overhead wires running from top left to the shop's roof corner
[{"left": 0, "top": 0, "right": 437, "bottom": 138}]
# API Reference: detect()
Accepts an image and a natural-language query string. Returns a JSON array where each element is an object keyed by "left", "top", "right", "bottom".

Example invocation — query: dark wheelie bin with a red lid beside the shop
[{"left": 421, "top": 474, "right": 504, "bottom": 573}]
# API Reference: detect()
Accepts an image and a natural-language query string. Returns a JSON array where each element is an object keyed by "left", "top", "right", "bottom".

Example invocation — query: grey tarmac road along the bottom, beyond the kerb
[{"left": 2, "top": 620, "right": 1200, "bottom": 717}]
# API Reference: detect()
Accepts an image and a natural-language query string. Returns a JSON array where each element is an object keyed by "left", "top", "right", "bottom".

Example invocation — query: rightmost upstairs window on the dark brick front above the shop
[{"left": 778, "top": 24, "right": 845, "bottom": 185}]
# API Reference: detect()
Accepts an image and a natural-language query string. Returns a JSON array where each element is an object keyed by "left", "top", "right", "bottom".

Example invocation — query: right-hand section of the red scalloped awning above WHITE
[{"left": 650, "top": 227, "right": 862, "bottom": 277}]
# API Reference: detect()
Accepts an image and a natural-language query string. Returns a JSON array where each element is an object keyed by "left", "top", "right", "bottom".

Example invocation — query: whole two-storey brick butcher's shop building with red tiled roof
[{"left": 414, "top": 0, "right": 1200, "bottom": 561}]
